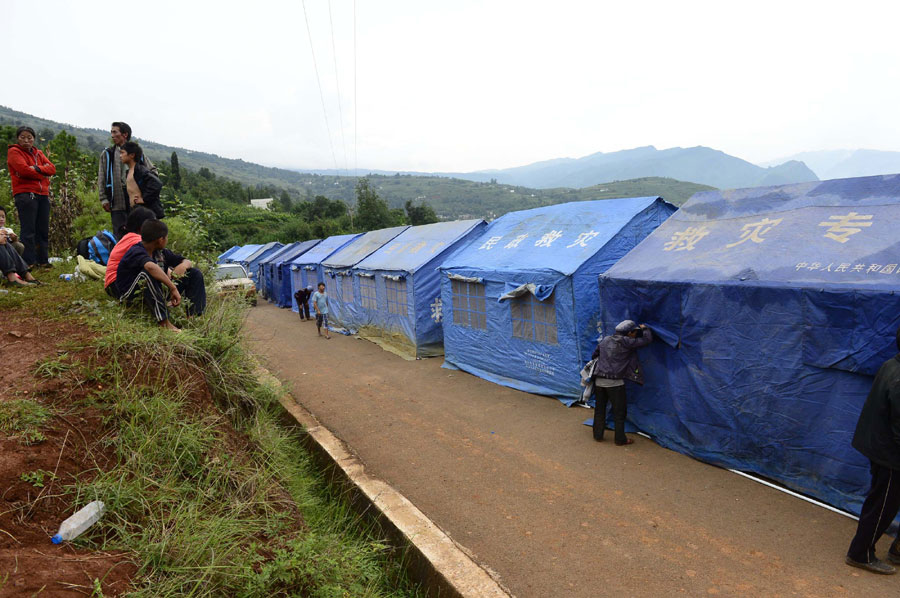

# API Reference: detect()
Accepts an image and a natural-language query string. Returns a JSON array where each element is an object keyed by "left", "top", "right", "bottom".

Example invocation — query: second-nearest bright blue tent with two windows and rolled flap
[{"left": 441, "top": 197, "right": 675, "bottom": 399}]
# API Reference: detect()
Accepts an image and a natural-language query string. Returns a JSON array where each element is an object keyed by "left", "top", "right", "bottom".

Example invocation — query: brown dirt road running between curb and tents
[{"left": 248, "top": 304, "right": 900, "bottom": 598}]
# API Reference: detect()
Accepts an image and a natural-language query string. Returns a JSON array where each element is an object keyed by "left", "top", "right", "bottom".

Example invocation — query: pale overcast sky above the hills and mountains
[{"left": 0, "top": 0, "right": 900, "bottom": 171}]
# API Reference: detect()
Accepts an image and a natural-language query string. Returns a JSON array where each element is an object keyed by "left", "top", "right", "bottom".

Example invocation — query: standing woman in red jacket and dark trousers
[{"left": 6, "top": 127, "right": 56, "bottom": 267}]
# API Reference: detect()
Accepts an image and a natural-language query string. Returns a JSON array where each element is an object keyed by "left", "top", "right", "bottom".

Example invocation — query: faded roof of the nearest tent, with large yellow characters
[{"left": 607, "top": 175, "right": 900, "bottom": 289}]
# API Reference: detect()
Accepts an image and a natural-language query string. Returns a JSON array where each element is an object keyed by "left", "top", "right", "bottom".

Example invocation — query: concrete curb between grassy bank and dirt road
[{"left": 260, "top": 372, "right": 513, "bottom": 598}]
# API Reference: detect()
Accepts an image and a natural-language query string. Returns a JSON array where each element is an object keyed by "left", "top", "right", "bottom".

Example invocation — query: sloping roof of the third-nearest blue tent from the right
[{"left": 356, "top": 220, "right": 484, "bottom": 272}]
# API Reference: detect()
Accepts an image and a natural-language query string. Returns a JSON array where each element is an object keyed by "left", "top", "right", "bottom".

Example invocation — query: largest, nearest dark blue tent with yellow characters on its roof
[{"left": 600, "top": 175, "right": 900, "bottom": 513}]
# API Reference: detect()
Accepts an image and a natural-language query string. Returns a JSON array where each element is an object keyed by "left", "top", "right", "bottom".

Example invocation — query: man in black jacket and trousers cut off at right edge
[{"left": 846, "top": 330, "right": 900, "bottom": 575}]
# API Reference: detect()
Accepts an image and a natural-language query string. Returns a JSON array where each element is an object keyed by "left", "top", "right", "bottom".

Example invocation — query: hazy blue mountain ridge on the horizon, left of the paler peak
[{"left": 440, "top": 146, "right": 818, "bottom": 189}]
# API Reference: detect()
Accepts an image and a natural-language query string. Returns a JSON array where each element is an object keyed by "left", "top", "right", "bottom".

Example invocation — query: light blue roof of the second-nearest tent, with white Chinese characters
[{"left": 441, "top": 196, "right": 663, "bottom": 274}]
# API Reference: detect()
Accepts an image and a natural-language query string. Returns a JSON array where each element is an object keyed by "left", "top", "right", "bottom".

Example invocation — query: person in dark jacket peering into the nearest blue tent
[{"left": 591, "top": 320, "right": 653, "bottom": 446}]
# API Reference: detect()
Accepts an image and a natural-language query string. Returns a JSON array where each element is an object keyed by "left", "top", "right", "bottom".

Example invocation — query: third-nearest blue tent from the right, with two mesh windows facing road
[{"left": 340, "top": 220, "right": 487, "bottom": 357}]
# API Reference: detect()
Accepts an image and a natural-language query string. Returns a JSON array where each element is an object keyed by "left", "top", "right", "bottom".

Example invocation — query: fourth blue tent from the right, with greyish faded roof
[{"left": 322, "top": 226, "right": 409, "bottom": 326}]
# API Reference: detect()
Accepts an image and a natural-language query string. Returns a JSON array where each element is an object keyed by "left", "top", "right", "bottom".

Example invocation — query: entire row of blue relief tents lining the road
[{"left": 216, "top": 176, "right": 900, "bottom": 524}]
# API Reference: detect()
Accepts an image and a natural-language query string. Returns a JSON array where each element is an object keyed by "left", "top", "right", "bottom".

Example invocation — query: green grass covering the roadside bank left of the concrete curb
[{"left": 0, "top": 270, "right": 419, "bottom": 598}]
